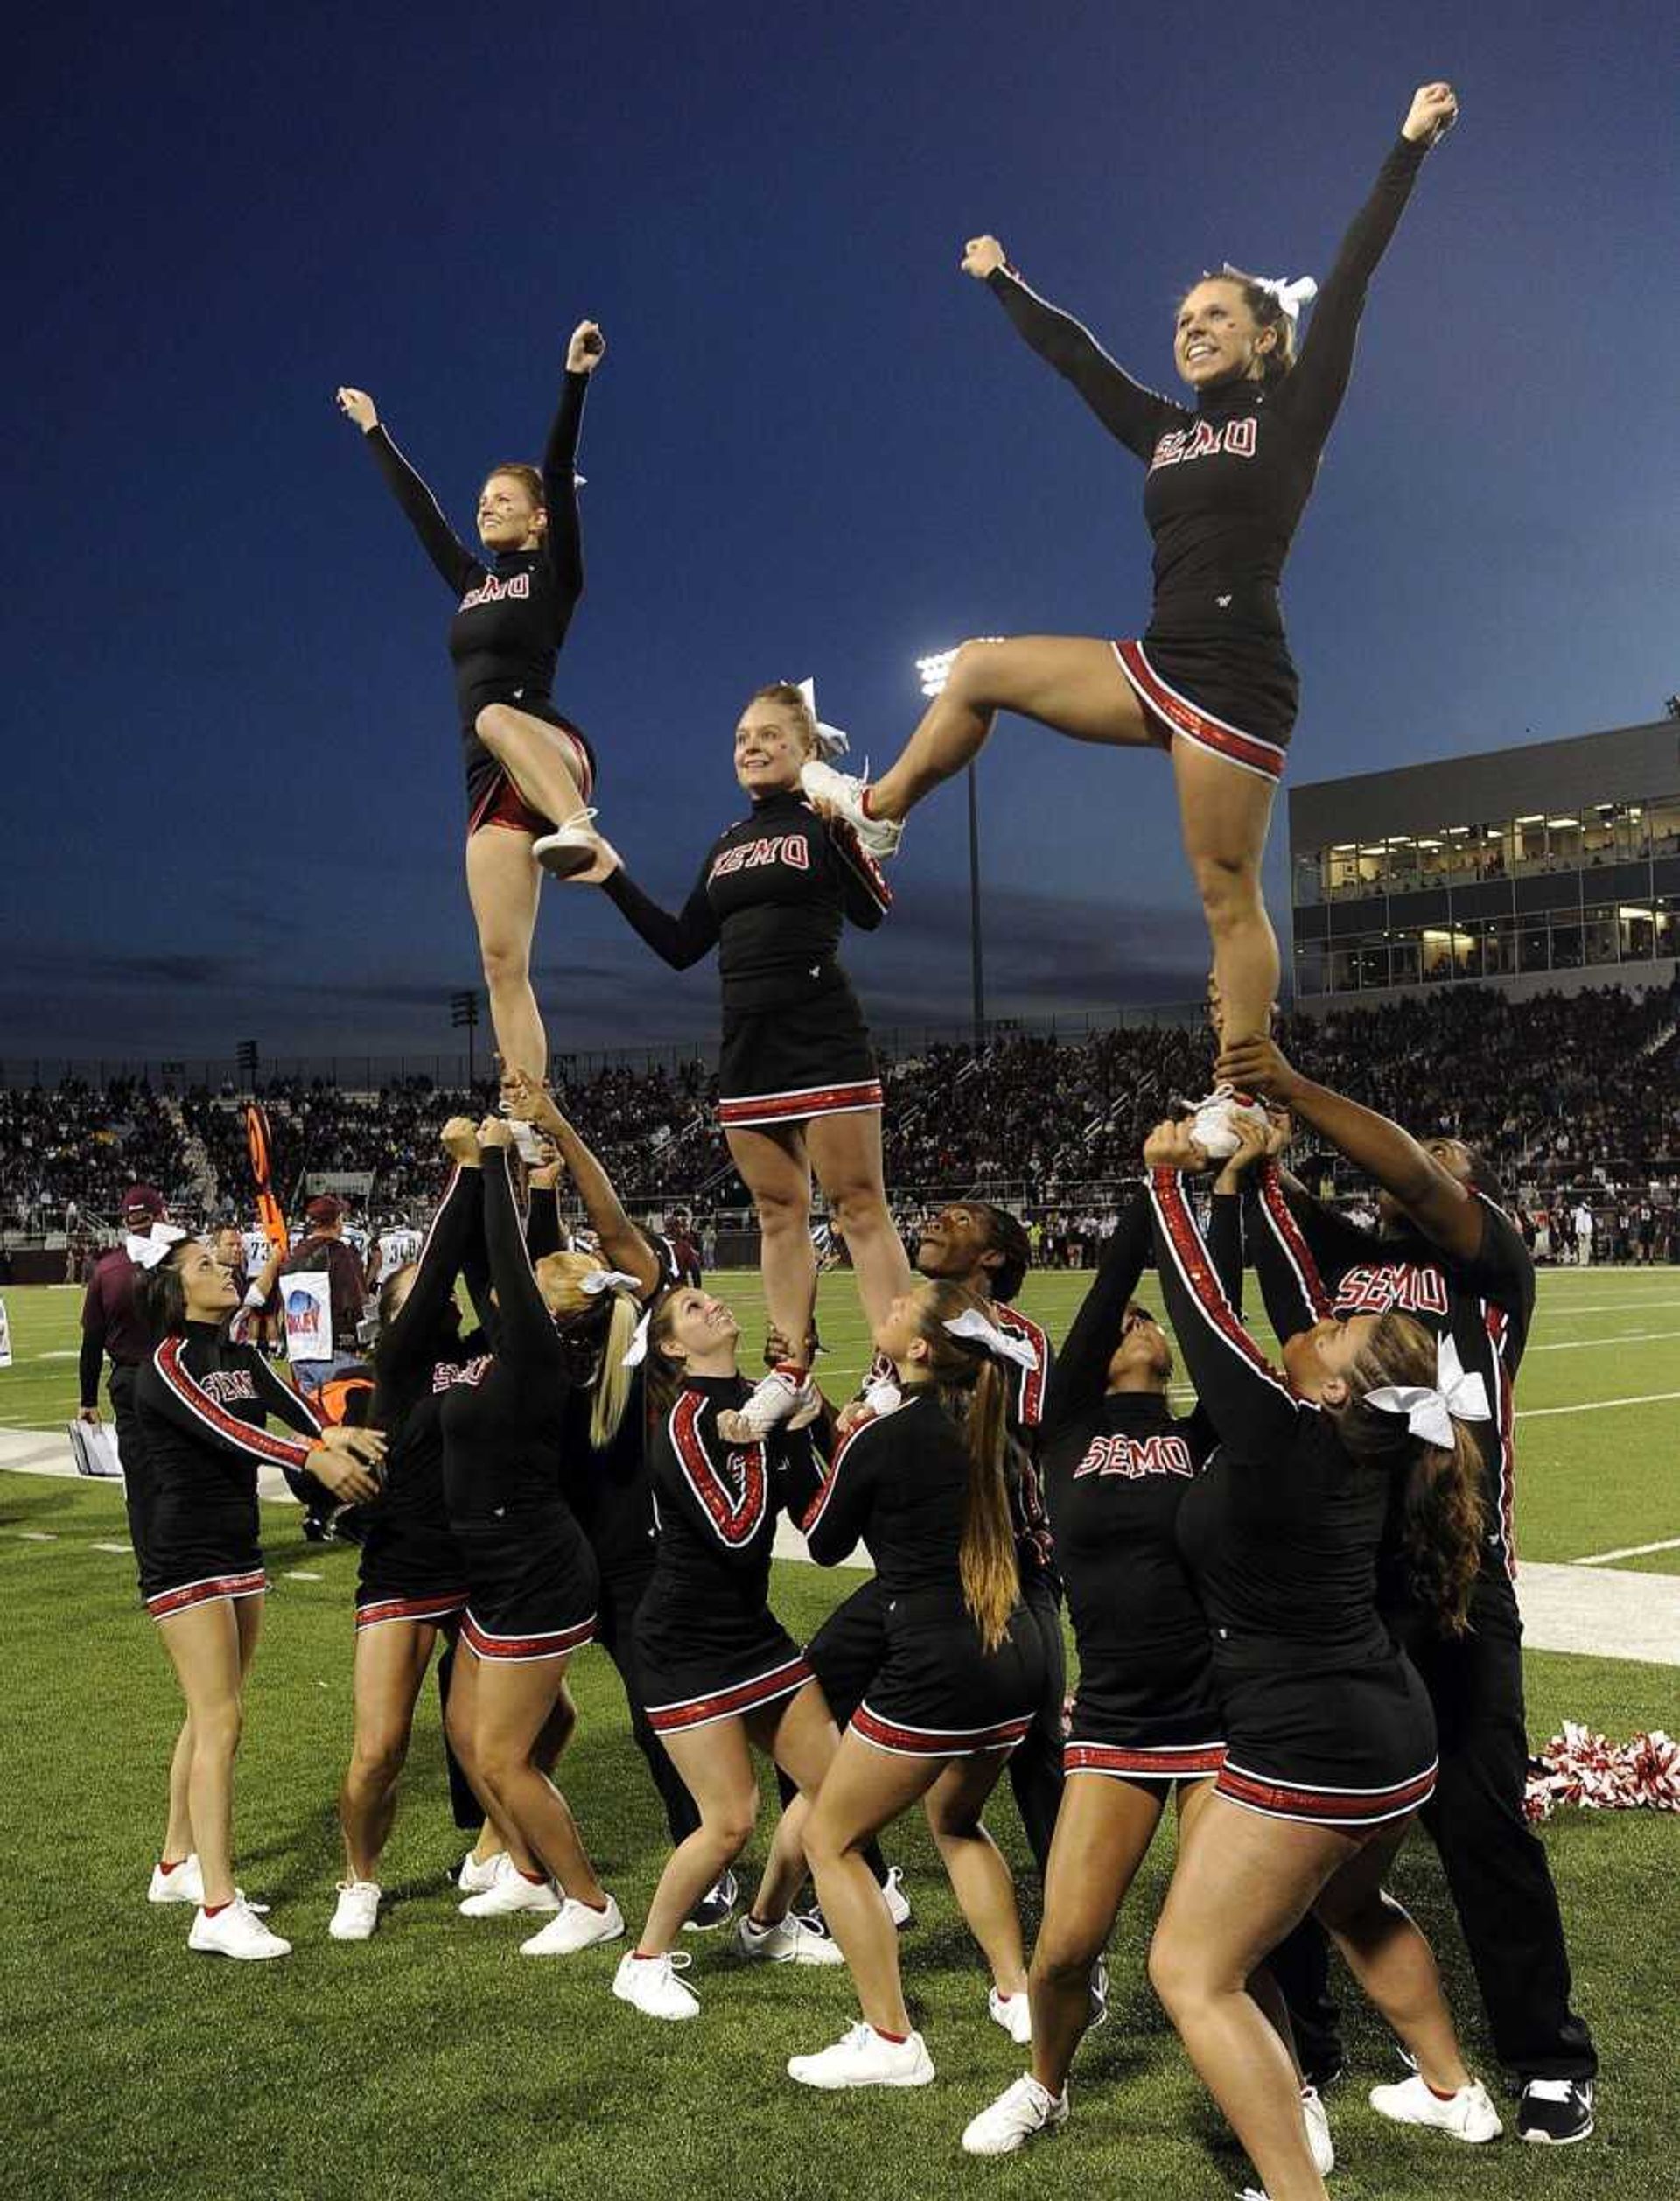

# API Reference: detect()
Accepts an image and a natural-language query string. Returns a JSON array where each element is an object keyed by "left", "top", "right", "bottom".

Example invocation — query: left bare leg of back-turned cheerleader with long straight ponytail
[{"left": 806, "top": 1728, "right": 947, "bottom": 2038}]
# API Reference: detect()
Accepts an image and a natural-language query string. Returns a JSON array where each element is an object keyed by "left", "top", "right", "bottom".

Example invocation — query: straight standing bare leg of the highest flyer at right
[{"left": 1173, "top": 738, "right": 1279, "bottom": 1048}]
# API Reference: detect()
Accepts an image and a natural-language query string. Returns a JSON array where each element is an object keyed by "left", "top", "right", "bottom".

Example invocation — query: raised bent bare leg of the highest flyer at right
[{"left": 870, "top": 634, "right": 1154, "bottom": 819}]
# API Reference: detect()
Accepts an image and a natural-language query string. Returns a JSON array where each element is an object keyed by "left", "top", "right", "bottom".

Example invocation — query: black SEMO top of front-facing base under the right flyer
[{"left": 1044, "top": 1193, "right": 1242, "bottom": 1675}]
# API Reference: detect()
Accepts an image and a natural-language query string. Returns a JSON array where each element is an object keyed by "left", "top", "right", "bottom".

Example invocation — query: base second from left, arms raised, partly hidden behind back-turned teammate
[{"left": 328, "top": 1116, "right": 482, "bottom": 1941}]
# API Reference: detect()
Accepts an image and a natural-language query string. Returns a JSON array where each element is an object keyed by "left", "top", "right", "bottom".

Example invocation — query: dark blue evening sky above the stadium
[{"left": 0, "top": 0, "right": 1680, "bottom": 1056}]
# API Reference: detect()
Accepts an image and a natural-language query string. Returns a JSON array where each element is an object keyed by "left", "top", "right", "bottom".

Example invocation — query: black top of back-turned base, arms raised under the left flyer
[{"left": 443, "top": 1146, "right": 579, "bottom": 1521}]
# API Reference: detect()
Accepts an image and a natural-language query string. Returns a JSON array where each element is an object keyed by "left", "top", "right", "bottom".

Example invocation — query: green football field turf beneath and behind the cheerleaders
[{"left": 0, "top": 1270, "right": 1680, "bottom": 2201}]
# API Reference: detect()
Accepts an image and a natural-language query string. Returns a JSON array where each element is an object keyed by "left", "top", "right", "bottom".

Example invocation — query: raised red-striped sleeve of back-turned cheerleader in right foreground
[{"left": 1145, "top": 1140, "right": 1306, "bottom": 1461}]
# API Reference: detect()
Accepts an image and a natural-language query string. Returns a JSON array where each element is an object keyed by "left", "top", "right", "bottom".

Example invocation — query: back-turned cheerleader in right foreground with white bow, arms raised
[{"left": 1145, "top": 1123, "right": 1500, "bottom": 2201}]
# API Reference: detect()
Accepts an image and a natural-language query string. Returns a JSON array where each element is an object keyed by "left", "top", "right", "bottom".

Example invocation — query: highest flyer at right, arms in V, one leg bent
[{"left": 803, "top": 84, "right": 1458, "bottom": 1074}]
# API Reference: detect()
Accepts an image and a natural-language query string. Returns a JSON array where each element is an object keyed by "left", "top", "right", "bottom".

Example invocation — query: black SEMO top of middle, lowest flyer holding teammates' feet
[{"left": 603, "top": 788, "right": 892, "bottom": 1014}]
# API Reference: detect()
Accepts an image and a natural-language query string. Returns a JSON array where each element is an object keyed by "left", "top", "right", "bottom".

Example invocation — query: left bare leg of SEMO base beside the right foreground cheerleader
[{"left": 1031, "top": 1774, "right": 1167, "bottom": 2093}]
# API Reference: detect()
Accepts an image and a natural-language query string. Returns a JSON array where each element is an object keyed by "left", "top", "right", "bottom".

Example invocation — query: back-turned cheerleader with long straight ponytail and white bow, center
[{"left": 788, "top": 1283, "right": 1044, "bottom": 2089}]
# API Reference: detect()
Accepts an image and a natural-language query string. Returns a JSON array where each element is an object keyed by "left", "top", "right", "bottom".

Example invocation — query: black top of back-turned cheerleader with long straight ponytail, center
[{"left": 802, "top": 1386, "right": 999, "bottom": 1600}]
